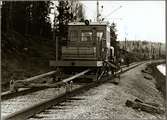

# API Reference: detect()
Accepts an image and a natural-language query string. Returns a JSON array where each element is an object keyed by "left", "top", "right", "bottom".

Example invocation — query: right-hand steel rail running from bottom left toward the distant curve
[{"left": 3, "top": 62, "right": 145, "bottom": 120}]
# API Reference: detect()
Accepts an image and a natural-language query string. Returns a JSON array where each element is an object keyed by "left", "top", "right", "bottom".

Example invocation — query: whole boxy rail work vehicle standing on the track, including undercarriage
[{"left": 50, "top": 20, "right": 117, "bottom": 80}]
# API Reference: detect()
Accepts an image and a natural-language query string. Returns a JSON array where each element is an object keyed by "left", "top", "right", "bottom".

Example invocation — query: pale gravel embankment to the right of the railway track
[{"left": 29, "top": 61, "right": 165, "bottom": 120}]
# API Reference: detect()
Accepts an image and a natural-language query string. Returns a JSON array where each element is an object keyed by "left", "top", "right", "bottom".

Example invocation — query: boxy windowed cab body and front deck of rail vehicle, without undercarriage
[{"left": 50, "top": 22, "right": 111, "bottom": 67}]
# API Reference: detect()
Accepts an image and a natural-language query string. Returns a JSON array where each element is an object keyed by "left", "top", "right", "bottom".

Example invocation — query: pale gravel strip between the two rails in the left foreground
[{"left": 1, "top": 85, "right": 80, "bottom": 118}]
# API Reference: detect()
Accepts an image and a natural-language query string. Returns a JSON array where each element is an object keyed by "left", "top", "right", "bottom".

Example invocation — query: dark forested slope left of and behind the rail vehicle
[{"left": 1, "top": 0, "right": 87, "bottom": 91}]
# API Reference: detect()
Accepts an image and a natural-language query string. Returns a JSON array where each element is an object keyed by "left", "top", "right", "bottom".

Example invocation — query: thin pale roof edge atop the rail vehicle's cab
[{"left": 68, "top": 22, "right": 108, "bottom": 26}]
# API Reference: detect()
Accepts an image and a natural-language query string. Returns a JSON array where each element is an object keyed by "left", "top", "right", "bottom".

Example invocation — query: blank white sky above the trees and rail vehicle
[{"left": 81, "top": 0, "right": 166, "bottom": 43}]
